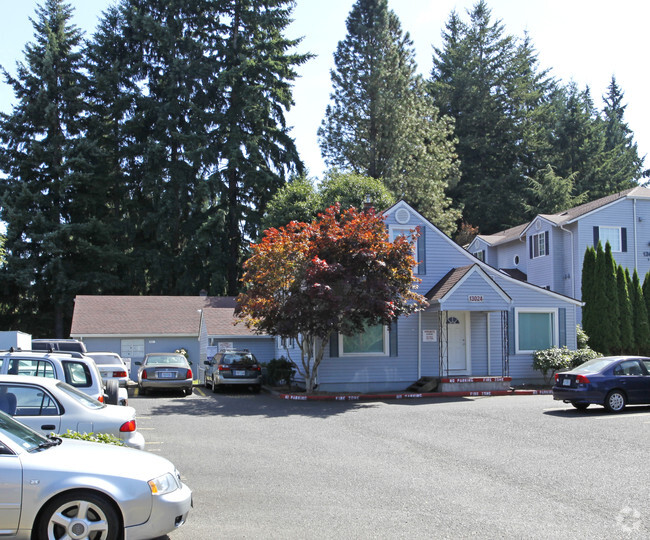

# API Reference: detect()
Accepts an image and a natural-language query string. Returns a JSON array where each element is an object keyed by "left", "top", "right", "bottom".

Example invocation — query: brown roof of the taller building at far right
[{"left": 470, "top": 186, "right": 650, "bottom": 246}]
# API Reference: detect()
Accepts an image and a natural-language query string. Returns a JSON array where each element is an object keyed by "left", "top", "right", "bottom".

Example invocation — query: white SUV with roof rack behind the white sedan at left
[{"left": 0, "top": 350, "right": 105, "bottom": 404}]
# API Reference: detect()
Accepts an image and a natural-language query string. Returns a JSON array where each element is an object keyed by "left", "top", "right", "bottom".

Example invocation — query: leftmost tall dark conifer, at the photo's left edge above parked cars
[{"left": 0, "top": 0, "right": 89, "bottom": 337}]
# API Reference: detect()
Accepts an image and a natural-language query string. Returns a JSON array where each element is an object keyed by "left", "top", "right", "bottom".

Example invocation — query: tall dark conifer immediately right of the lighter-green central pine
[{"left": 430, "top": 0, "right": 552, "bottom": 234}]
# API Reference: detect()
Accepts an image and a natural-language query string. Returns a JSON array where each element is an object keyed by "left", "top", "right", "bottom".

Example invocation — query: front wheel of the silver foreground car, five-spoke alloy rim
[{"left": 37, "top": 492, "right": 120, "bottom": 540}]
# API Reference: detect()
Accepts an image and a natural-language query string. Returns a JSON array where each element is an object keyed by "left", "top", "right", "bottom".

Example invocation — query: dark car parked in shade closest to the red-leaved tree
[{"left": 204, "top": 350, "right": 262, "bottom": 392}]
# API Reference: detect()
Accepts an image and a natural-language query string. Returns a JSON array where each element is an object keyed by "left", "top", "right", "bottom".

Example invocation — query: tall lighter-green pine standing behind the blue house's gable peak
[{"left": 318, "top": 0, "right": 460, "bottom": 233}]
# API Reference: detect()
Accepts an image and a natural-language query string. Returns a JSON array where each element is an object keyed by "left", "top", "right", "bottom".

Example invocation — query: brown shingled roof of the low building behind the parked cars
[{"left": 70, "top": 295, "right": 253, "bottom": 337}]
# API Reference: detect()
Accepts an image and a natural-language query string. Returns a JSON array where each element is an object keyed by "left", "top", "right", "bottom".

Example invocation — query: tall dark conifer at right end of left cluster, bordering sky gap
[{"left": 210, "top": 0, "right": 310, "bottom": 294}]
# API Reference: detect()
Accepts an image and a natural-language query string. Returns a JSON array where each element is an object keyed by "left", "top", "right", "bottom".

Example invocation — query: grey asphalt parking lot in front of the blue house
[{"left": 129, "top": 389, "right": 650, "bottom": 540}]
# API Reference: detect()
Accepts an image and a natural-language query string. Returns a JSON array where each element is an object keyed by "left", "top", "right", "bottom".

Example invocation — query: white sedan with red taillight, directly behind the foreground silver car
[{"left": 0, "top": 375, "right": 144, "bottom": 450}]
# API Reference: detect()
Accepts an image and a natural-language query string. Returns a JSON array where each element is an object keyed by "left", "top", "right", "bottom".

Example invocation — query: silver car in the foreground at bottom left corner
[{"left": 0, "top": 407, "right": 192, "bottom": 540}]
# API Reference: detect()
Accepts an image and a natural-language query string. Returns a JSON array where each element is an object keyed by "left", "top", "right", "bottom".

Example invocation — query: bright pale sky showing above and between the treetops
[{"left": 0, "top": 0, "right": 650, "bottom": 178}]
